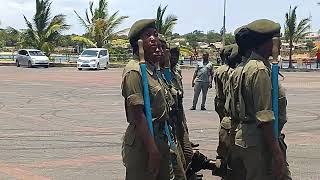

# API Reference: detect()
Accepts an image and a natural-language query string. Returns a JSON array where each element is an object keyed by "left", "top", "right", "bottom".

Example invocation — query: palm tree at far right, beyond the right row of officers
[{"left": 284, "top": 6, "right": 310, "bottom": 68}]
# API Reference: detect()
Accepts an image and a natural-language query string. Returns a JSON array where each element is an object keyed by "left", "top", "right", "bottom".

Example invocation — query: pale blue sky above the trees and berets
[{"left": 0, "top": 0, "right": 320, "bottom": 34}]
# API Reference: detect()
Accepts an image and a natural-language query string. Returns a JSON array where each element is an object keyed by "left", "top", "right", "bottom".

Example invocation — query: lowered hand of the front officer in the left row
[{"left": 148, "top": 148, "right": 161, "bottom": 179}]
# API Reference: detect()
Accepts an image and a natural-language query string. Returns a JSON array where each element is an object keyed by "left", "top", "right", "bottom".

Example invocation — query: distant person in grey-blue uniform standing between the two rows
[{"left": 190, "top": 52, "right": 213, "bottom": 111}]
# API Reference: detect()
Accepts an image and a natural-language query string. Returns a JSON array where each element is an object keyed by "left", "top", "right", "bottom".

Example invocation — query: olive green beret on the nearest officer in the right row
[{"left": 246, "top": 19, "right": 281, "bottom": 35}]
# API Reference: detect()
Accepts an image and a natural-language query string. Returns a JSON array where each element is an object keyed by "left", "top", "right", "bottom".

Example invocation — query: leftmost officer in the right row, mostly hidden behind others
[{"left": 215, "top": 44, "right": 245, "bottom": 180}]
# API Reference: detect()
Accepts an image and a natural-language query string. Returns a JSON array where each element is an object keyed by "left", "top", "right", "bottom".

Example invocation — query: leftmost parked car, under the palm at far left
[{"left": 16, "top": 49, "right": 49, "bottom": 68}]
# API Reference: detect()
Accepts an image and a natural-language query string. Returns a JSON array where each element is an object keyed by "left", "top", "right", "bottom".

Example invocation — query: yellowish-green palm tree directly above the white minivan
[{"left": 72, "top": 0, "right": 128, "bottom": 48}]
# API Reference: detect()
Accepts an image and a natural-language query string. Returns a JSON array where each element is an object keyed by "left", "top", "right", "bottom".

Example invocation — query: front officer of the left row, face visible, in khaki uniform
[{"left": 122, "top": 19, "right": 170, "bottom": 180}]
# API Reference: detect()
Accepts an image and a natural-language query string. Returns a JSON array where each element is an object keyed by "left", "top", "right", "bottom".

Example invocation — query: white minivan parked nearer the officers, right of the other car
[{"left": 77, "top": 48, "right": 109, "bottom": 70}]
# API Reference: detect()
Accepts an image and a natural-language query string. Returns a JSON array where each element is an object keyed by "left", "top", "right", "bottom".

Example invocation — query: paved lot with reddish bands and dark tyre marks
[{"left": 0, "top": 67, "right": 320, "bottom": 180}]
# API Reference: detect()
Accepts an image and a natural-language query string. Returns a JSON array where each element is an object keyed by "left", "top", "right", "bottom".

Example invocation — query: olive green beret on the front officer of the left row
[{"left": 128, "top": 19, "right": 156, "bottom": 43}]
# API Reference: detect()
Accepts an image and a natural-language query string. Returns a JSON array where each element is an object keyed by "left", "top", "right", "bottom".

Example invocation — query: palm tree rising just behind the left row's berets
[{"left": 156, "top": 5, "right": 178, "bottom": 37}]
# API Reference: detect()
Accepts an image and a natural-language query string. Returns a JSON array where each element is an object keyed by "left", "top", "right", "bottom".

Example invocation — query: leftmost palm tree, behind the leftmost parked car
[{"left": 23, "top": 0, "right": 70, "bottom": 55}]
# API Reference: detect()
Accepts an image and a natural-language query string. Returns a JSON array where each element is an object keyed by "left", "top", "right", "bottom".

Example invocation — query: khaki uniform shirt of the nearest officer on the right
[{"left": 235, "top": 52, "right": 274, "bottom": 148}]
